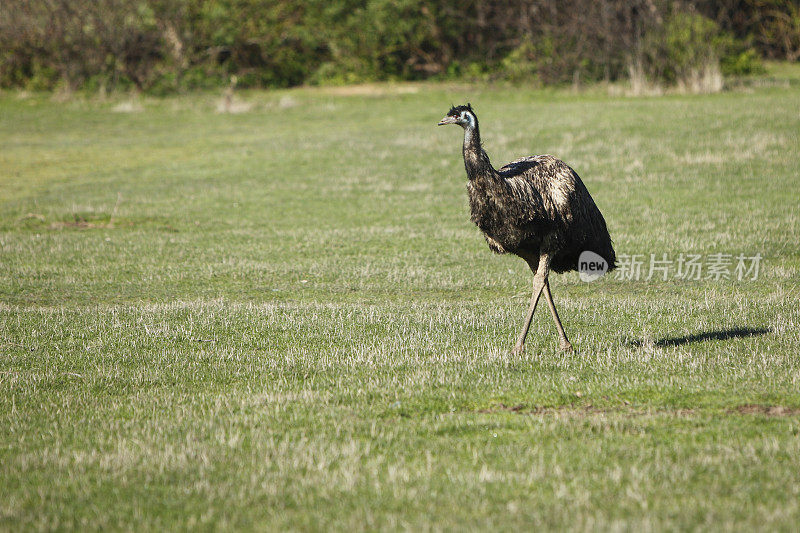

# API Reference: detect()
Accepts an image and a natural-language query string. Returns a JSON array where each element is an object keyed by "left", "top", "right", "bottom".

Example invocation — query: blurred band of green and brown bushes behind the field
[{"left": 0, "top": 0, "right": 800, "bottom": 93}]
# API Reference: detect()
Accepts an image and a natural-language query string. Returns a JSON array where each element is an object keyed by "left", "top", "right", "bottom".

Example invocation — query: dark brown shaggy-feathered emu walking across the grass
[{"left": 439, "top": 104, "right": 616, "bottom": 354}]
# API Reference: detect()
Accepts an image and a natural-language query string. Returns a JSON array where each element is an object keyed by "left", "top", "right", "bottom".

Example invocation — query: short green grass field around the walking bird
[{"left": 0, "top": 67, "right": 800, "bottom": 531}]
